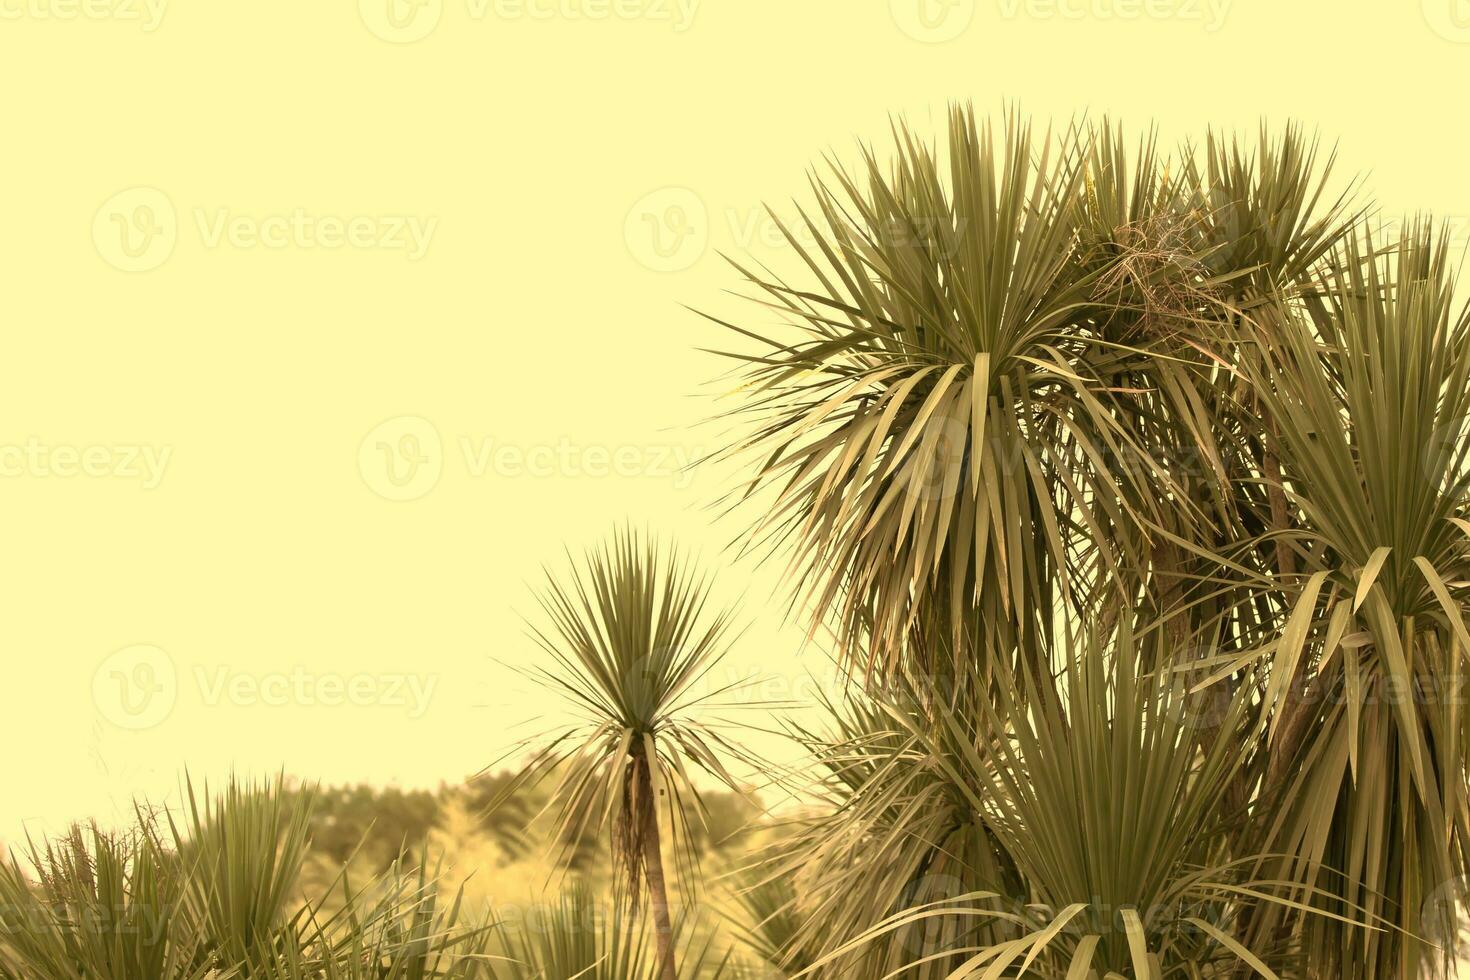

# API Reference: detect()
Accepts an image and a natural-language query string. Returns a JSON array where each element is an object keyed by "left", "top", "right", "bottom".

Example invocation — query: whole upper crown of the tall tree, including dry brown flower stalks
[{"left": 705, "top": 109, "right": 1351, "bottom": 696}]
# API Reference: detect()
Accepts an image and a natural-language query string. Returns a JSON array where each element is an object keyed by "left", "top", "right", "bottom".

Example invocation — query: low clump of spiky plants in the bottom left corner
[{"left": 0, "top": 779, "right": 494, "bottom": 980}]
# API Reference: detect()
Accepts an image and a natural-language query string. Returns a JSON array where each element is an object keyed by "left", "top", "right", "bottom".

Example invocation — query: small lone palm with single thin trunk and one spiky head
[{"left": 498, "top": 530, "right": 746, "bottom": 980}]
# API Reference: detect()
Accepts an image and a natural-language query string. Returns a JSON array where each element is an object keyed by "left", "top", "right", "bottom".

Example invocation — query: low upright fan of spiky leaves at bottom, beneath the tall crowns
[{"left": 817, "top": 624, "right": 1361, "bottom": 980}]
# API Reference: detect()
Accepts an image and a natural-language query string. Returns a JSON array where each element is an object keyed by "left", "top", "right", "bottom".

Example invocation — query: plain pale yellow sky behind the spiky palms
[{"left": 0, "top": 0, "right": 1470, "bottom": 840}]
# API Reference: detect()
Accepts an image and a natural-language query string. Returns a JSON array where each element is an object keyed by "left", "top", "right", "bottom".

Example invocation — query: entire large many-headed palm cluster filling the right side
[{"left": 705, "top": 109, "right": 1470, "bottom": 977}]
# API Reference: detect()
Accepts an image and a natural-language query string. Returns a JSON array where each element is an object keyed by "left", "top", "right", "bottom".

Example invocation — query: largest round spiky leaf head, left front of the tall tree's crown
[{"left": 705, "top": 103, "right": 1111, "bottom": 670}]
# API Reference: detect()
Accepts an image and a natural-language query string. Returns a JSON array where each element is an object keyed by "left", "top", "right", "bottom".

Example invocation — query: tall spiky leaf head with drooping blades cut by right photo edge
[{"left": 1254, "top": 225, "right": 1470, "bottom": 977}]
